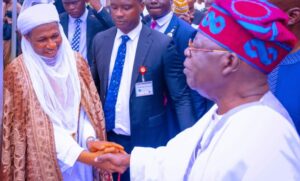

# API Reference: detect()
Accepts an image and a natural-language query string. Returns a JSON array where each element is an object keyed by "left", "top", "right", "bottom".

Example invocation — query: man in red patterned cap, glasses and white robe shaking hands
[{"left": 97, "top": 0, "right": 300, "bottom": 181}]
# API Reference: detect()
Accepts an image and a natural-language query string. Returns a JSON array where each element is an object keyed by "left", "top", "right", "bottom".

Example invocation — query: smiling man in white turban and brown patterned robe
[{"left": 0, "top": 0, "right": 123, "bottom": 181}]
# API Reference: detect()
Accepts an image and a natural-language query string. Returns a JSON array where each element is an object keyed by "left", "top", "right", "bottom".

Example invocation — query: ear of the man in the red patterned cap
[{"left": 221, "top": 53, "right": 240, "bottom": 76}]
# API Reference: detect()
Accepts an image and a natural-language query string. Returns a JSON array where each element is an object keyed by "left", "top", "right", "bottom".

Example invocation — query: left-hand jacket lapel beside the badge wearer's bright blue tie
[{"left": 98, "top": 28, "right": 117, "bottom": 96}]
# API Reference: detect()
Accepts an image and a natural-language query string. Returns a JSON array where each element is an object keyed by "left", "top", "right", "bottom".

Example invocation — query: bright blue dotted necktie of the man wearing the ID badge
[{"left": 104, "top": 35, "right": 130, "bottom": 131}]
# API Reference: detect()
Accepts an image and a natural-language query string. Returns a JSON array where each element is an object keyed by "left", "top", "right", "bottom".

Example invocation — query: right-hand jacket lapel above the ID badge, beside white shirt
[{"left": 130, "top": 25, "right": 152, "bottom": 95}]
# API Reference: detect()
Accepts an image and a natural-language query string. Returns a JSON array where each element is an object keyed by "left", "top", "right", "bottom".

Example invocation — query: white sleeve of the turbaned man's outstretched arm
[{"left": 54, "top": 126, "right": 84, "bottom": 172}]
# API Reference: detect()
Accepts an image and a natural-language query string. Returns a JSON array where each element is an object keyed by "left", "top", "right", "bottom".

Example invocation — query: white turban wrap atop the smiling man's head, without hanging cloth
[{"left": 17, "top": 4, "right": 59, "bottom": 35}]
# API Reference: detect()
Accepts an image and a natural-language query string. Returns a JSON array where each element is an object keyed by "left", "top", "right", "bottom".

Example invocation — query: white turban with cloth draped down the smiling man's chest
[{"left": 17, "top": 0, "right": 81, "bottom": 135}]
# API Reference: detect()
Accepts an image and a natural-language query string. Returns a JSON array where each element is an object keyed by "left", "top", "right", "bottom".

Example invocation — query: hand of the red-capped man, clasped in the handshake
[{"left": 94, "top": 153, "right": 130, "bottom": 174}]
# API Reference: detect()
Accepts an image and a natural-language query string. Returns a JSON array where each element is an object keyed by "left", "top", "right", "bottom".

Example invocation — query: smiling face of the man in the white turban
[{"left": 25, "top": 22, "right": 62, "bottom": 58}]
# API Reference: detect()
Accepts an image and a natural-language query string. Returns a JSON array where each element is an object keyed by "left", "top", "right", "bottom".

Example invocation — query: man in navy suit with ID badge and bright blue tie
[{"left": 92, "top": 0, "right": 195, "bottom": 180}]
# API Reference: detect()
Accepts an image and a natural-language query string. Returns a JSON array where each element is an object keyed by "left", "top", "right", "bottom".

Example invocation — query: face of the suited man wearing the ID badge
[{"left": 110, "top": 0, "right": 144, "bottom": 34}]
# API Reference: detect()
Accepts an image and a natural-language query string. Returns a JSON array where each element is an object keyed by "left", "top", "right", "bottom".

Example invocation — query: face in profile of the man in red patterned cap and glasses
[{"left": 184, "top": 33, "right": 232, "bottom": 98}]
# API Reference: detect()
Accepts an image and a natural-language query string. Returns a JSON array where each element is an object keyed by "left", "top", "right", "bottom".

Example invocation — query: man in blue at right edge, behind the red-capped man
[{"left": 269, "top": 0, "right": 300, "bottom": 135}]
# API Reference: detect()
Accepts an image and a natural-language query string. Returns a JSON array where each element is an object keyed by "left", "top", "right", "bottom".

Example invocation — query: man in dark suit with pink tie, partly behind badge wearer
[{"left": 144, "top": 0, "right": 212, "bottom": 137}]
